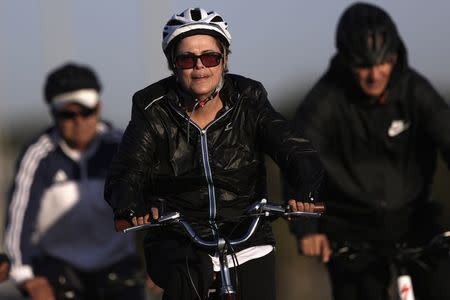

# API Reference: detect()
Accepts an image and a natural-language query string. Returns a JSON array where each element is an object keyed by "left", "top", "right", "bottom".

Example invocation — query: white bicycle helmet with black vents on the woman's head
[{"left": 162, "top": 8, "right": 231, "bottom": 53}]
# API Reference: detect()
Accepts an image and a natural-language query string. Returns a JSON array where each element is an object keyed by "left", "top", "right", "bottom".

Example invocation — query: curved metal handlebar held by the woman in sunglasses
[{"left": 123, "top": 199, "right": 325, "bottom": 248}]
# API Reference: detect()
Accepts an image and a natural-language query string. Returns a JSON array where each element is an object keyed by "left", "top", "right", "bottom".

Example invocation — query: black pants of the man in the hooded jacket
[{"left": 328, "top": 252, "right": 450, "bottom": 300}]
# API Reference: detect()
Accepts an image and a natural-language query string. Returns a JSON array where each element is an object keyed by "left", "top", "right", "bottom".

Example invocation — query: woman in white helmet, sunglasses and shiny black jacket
[{"left": 105, "top": 8, "right": 322, "bottom": 300}]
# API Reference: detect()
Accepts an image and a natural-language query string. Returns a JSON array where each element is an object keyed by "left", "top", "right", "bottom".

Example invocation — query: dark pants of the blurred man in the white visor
[{"left": 33, "top": 257, "right": 145, "bottom": 300}]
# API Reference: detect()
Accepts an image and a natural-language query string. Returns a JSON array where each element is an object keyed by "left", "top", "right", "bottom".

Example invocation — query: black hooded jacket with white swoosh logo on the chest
[{"left": 295, "top": 47, "right": 450, "bottom": 240}]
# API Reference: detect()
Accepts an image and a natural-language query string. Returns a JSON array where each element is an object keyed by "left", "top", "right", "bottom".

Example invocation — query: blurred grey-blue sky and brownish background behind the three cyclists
[{"left": 0, "top": 0, "right": 450, "bottom": 300}]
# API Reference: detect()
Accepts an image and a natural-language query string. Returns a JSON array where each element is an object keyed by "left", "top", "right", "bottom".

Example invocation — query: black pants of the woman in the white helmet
[{"left": 145, "top": 234, "right": 276, "bottom": 300}]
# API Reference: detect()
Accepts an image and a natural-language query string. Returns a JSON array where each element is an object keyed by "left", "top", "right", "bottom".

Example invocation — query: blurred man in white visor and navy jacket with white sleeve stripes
[{"left": 5, "top": 63, "right": 144, "bottom": 300}]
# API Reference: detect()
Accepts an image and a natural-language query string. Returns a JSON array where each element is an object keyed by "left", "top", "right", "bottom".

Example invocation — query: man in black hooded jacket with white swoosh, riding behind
[{"left": 294, "top": 3, "right": 450, "bottom": 300}]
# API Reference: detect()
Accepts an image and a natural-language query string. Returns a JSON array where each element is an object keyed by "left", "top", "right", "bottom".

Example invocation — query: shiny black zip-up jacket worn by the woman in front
[{"left": 105, "top": 74, "right": 322, "bottom": 248}]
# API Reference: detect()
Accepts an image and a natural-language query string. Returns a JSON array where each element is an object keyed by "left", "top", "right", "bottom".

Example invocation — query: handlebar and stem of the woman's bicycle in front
[{"left": 123, "top": 199, "right": 324, "bottom": 300}]
